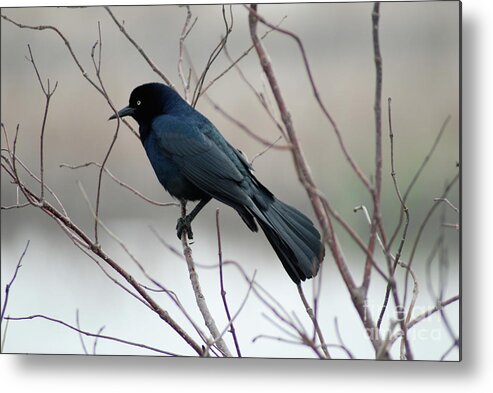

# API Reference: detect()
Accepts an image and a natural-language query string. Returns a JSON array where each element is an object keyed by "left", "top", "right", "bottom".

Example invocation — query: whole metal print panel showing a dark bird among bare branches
[{"left": 1, "top": 1, "right": 461, "bottom": 361}]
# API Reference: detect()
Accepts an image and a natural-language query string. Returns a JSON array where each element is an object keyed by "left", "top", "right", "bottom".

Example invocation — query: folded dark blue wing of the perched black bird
[{"left": 152, "top": 116, "right": 247, "bottom": 204}]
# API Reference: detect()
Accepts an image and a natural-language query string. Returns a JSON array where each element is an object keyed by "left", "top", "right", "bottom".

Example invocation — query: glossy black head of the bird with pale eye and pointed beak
[{"left": 108, "top": 83, "right": 186, "bottom": 125}]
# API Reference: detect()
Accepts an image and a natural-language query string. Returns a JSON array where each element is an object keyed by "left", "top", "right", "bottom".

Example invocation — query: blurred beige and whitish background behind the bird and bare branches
[{"left": 1, "top": 2, "right": 460, "bottom": 360}]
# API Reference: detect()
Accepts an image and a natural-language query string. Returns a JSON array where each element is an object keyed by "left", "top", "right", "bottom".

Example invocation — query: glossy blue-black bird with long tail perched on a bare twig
[{"left": 110, "top": 83, "right": 324, "bottom": 284}]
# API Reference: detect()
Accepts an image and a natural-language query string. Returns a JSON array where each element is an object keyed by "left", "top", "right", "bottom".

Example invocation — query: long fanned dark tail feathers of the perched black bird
[{"left": 251, "top": 193, "right": 325, "bottom": 284}]
